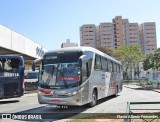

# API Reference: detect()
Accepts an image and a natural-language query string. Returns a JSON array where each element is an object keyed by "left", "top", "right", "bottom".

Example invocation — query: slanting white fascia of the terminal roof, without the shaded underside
[{"left": 0, "top": 25, "right": 47, "bottom": 58}]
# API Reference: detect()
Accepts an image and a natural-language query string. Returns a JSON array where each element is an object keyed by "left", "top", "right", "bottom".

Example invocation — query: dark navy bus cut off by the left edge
[{"left": 0, "top": 55, "right": 24, "bottom": 99}]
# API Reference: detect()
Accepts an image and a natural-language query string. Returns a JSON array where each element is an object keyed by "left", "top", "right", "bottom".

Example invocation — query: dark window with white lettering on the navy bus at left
[{"left": 0, "top": 58, "right": 20, "bottom": 77}]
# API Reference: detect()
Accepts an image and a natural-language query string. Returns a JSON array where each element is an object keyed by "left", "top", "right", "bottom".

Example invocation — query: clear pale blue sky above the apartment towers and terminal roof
[{"left": 0, "top": 0, "right": 160, "bottom": 50}]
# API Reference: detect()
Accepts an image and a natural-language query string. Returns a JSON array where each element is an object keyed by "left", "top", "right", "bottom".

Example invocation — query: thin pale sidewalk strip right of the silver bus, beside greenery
[{"left": 123, "top": 84, "right": 160, "bottom": 93}]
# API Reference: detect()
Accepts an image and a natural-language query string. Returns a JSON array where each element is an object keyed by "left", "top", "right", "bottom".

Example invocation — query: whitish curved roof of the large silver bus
[{"left": 45, "top": 46, "right": 121, "bottom": 64}]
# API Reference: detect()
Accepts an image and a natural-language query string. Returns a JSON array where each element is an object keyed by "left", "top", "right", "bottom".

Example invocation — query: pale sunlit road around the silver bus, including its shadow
[{"left": 0, "top": 87, "right": 160, "bottom": 120}]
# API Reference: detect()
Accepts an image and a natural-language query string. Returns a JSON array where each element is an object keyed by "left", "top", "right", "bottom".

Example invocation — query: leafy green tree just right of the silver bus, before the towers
[{"left": 114, "top": 45, "right": 142, "bottom": 81}]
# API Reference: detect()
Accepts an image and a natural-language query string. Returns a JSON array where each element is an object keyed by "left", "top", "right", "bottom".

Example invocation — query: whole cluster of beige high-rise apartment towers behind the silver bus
[{"left": 80, "top": 16, "right": 157, "bottom": 54}]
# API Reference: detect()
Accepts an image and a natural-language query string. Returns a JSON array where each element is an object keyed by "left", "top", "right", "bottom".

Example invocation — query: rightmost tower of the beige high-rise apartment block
[{"left": 140, "top": 22, "right": 157, "bottom": 54}]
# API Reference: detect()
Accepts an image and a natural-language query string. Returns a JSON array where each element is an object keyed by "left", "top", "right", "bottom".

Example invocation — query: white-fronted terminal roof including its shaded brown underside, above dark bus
[{"left": 0, "top": 25, "right": 47, "bottom": 69}]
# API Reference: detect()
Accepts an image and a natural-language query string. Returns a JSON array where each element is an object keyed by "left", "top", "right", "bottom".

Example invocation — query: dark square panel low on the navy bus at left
[{"left": 3, "top": 83, "right": 18, "bottom": 97}]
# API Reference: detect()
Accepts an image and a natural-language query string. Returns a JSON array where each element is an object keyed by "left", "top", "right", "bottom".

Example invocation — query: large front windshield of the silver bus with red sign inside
[{"left": 39, "top": 52, "right": 80, "bottom": 88}]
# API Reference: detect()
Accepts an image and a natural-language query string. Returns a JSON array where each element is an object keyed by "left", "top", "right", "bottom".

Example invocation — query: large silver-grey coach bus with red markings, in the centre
[{"left": 32, "top": 47, "right": 122, "bottom": 107}]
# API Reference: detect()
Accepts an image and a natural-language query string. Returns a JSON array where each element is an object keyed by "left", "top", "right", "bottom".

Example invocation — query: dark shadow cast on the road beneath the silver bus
[{"left": 10, "top": 96, "right": 118, "bottom": 122}]
